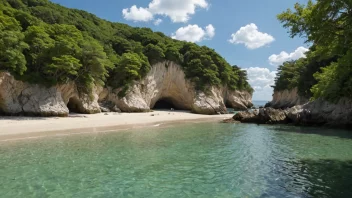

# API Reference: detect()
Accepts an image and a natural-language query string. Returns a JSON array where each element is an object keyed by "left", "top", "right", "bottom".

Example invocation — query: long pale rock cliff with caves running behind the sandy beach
[{"left": 0, "top": 61, "right": 252, "bottom": 116}]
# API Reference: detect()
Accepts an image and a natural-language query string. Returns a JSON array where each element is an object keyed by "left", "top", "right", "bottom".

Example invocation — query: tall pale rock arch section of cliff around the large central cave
[{"left": 99, "top": 61, "right": 252, "bottom": 114}]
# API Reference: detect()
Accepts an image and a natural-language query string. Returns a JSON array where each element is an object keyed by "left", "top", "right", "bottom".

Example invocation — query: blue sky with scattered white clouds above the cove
[{"left": 52, "top": 0, "right": 309, "bottom": 101}]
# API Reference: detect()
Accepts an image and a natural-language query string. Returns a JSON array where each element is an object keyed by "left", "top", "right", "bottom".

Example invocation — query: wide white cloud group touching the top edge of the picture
[{"left": 123, "top": 0, "right": 209, "bottom": 23}]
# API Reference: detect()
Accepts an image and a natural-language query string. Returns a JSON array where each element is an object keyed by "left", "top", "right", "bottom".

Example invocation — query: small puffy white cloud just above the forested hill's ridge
[{"left": 171, "top": 24, "right": 215, "bottom": 43}]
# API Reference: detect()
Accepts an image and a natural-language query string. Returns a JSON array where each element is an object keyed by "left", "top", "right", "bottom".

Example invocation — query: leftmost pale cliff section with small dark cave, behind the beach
[{"left": 0, "top": 72, "right": 100, "bottom": 116}]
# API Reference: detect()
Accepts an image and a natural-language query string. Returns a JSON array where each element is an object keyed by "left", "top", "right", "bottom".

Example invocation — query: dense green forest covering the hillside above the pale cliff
[{"left": 0, "top": 0, "right": 252, "bottom": 94}]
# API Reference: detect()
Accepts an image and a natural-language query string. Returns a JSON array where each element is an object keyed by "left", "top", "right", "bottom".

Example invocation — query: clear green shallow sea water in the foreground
[{"left": 0, "top": 123, "right": 352, "bottom": 198}]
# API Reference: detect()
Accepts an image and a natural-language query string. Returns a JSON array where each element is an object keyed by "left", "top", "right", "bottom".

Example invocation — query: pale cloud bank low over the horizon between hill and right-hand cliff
[{"left": 245, "top": 67, "right": 276, "bottom": 101}]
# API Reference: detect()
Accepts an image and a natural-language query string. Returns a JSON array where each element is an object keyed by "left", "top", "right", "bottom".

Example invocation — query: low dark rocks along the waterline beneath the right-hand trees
[{"left": 233, "top": 98, "right": 352, "bottom": 128}]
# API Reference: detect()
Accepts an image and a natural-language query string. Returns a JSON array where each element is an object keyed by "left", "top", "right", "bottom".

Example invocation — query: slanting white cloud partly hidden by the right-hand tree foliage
[{"left": 269, "top": 47, "right": 309, "bottom": 65}]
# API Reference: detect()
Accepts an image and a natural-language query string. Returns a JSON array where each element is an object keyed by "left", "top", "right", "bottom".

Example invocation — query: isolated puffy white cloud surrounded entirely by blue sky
[{"left": 229, "top": 23, "right": 275, "bottom": 49}]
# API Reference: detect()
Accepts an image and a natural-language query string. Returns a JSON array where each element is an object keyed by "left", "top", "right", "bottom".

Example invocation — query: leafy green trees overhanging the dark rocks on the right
[{"left": 274, "top": 0, "right": 352, "bottom": 101}]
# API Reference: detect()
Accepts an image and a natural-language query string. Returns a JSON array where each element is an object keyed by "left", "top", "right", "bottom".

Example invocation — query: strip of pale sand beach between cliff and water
[{"left": 0, "top": 111, "right": 231, "bottom": 140}]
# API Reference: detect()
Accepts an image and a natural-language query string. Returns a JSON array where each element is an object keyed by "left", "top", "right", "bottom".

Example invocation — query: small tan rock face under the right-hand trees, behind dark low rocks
[{"left": 265, "top": 88, "right": 308, "bottom": 109}]
